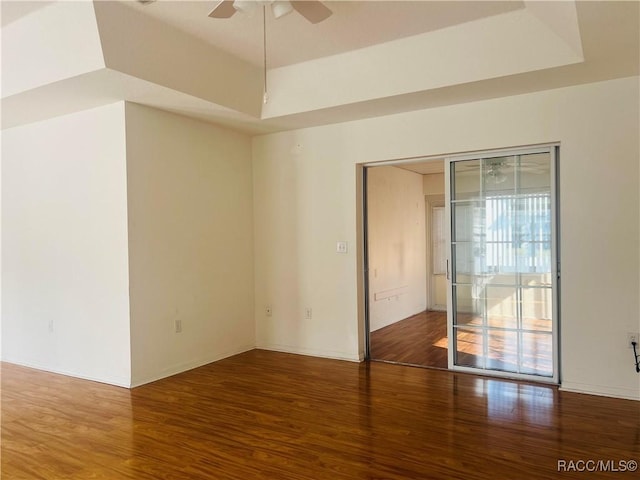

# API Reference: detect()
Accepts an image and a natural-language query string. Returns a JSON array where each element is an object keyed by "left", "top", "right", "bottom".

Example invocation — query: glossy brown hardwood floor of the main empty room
[{"left": 1, "top": 350, "right": 640, "bottom": 480}]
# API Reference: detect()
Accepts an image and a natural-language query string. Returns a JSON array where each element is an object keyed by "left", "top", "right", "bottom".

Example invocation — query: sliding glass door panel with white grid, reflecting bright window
[{"left": 447, "top": 147, "right": 558, "bottom": 381}]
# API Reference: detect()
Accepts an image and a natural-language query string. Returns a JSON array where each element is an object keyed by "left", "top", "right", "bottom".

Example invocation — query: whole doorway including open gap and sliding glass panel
[{"left": 364, "top": 145, "right": 559, "bottom": 383}]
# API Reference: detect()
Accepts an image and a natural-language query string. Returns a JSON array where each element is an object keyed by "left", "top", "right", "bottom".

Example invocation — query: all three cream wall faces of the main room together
[{"left": 2, "top": 77, "right": 640, "bottom": 399}]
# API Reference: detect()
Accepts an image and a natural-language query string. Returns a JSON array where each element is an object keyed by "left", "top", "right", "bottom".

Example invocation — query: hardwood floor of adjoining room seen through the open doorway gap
[{"left": 369, "top": 311, "right": 447, "bottom": 368}]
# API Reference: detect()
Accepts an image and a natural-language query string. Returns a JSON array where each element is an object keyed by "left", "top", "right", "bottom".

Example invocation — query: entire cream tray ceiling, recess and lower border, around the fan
[{"left": 0, "top": 0, "right": 640, "bottom": 134}]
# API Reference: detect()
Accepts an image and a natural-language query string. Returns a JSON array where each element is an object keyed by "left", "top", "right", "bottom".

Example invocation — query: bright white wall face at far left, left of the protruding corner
[{"left": 2, "top": 103, "right": 130, "bottom": 386}]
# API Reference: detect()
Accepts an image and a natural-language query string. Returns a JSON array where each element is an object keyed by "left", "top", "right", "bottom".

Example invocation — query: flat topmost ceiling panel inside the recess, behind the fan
[{"left": 127, "top": 0, "right": 524, "bottom": 68}]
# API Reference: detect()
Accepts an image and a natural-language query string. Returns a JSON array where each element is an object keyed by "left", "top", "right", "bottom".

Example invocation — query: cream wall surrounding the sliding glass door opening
[{"left": 253, "top": 77, "right": 640, "bottom": 399}]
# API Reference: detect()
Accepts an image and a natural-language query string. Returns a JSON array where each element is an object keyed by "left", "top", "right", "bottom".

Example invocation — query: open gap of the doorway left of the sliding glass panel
[{"left": 366, "top": 159, "right": 448, "bottom": 369}]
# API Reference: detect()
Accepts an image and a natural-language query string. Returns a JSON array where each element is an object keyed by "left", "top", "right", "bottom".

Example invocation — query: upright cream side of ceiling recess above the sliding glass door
[{"left": 262, "top": 2, "right": 583, "bottom": 118}]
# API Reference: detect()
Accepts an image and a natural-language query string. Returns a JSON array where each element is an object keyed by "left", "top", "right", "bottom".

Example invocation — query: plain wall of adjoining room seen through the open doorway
[{"left": 367, "top": 167, "right": 427, "bottom": 332}]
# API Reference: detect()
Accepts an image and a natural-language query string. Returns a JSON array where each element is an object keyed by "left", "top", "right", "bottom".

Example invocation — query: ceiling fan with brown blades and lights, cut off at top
[{"left": 209, "top": 0, "right": 333, "bottom": 23}]
